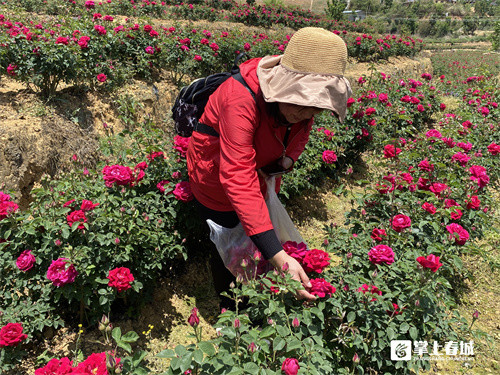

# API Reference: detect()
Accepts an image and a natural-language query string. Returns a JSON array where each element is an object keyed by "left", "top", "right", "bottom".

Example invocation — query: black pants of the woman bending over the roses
[{"left": 195, "top": 201, "right": 240, "bottom": 310}]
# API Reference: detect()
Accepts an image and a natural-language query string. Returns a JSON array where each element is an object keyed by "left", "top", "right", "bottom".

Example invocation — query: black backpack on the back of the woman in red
[{"left": 172, "top": 52, "right": 255, "bottom": 137}]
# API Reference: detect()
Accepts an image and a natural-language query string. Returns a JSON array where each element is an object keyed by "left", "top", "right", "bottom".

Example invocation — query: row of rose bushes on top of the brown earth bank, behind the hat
[{"left": 0, "top": 9, "right": 422, "bottom": 96}]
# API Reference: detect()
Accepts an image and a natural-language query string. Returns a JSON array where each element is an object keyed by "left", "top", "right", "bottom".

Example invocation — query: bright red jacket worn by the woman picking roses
[{"left": 187, "top": 58, "right": 312, "bottom": 236}]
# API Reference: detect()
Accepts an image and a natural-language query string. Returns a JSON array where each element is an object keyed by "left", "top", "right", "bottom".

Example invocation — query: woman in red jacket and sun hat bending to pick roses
[{"left": 187, "top": 27, "right": 351, "bottom": 308}]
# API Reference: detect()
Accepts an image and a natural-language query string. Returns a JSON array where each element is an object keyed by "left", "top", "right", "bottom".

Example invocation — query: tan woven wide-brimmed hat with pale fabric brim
[{"left": 257, "top": 27, "right": 352, "bottom": 121}]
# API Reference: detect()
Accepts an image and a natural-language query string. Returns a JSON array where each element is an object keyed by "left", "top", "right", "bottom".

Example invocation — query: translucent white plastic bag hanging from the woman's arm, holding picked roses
[{"left": 207, "top": 177, "right": 304, "bottom": 279}]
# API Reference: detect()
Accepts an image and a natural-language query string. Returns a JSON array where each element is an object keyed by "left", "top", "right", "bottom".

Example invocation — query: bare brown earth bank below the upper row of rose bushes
[{"left": 0, "top": 56, "right": 432, "bottom": 208}]
